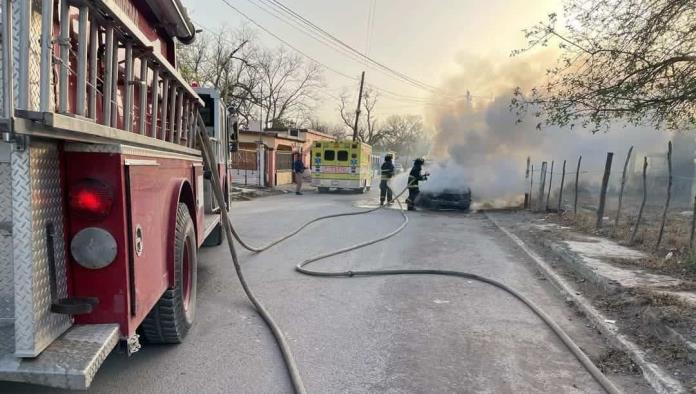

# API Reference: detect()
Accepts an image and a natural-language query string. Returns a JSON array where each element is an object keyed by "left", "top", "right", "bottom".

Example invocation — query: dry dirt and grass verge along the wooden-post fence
[{"left": 528, "top": 207, "right": 696, "bottom": 393}]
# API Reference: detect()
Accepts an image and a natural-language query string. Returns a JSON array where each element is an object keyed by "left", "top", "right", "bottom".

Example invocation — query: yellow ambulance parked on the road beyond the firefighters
[{"left": 311, "top": 141, "right": 373, "bottom": 193}]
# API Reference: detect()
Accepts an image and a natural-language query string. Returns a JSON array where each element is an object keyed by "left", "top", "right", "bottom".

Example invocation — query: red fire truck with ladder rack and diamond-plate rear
[{"left": 0, "top": 0, "right": 229, "bottom": 389}]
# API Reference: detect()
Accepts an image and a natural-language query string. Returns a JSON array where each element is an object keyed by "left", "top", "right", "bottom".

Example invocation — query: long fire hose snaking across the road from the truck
[{"left": 198, "top": 116, "right": 621, "bottom": 394}]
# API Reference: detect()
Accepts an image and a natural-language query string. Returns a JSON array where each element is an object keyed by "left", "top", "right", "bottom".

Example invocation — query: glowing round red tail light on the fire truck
[{"left": 70, "top": 179, "right": 114, "bottom": 218}]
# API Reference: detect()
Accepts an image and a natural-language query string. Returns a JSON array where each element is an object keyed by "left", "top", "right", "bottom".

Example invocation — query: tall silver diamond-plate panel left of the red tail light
[{"left": 11, "top": 142, "right": 72, "bottom": 357}]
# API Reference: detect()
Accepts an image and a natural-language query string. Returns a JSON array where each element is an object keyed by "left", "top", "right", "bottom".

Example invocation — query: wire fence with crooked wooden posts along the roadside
[{"left": 524, "top": 141, "right": 696, "bottom": 250}]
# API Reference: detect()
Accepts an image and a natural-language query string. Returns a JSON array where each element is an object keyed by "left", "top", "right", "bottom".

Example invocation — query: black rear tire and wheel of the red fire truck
[{"left": 142, "top": 204, "right": 198, "bottom": 343}]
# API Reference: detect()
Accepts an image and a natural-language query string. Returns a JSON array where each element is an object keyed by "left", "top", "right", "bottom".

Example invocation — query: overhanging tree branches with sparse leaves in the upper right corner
[{"left": 511, "top": 0, "right": 696, "bottom": 131}]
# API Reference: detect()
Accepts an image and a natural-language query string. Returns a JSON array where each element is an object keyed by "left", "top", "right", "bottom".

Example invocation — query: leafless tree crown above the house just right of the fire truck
[{"left": 179, "top": 26, "right": 322, "bottom": 127}]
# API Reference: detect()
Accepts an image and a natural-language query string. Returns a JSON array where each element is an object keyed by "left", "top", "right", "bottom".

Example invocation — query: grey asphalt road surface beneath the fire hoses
[{"left": 0, "top": 186, "right": 645, "bottom": 394}]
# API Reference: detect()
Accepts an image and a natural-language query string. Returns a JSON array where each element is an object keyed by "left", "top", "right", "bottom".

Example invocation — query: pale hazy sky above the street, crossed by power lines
[{"left": 183, "top": 0, "right": 561, "bottom": 123}]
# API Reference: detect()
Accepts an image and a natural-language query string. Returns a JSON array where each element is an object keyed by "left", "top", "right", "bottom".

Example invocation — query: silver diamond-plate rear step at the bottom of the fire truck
[{"left": 0, "top": 324, "right": 119, "bottom": 390}]
